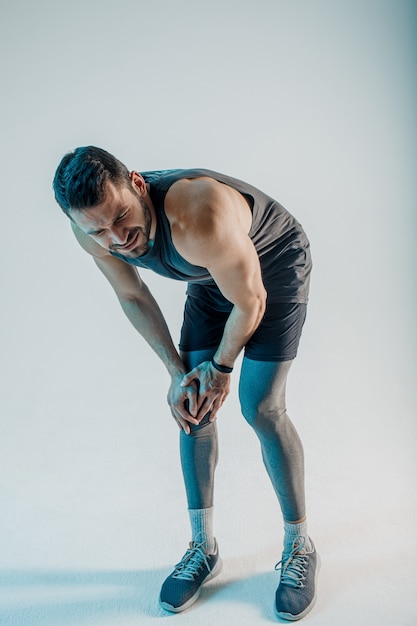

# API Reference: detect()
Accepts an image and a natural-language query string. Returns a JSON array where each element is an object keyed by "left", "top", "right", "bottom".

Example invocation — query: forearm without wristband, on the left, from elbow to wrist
[{"left": 115, "top": 284, "right": 185, "bottom": 376}]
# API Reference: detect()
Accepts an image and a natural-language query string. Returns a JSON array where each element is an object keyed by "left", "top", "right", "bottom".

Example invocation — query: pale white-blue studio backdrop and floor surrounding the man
[{"left": 0, "top": 0, "right": 417, "bottom": 626}]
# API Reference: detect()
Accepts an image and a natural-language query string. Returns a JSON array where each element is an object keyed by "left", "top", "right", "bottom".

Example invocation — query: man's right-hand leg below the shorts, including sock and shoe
[{"left": 239, "top": 357, "right": 318, "bottom": 620}]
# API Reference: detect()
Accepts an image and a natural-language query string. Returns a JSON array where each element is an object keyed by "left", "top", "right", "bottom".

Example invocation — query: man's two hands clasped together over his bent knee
[{"left": 168, "top": 361, "right": 230, "bottom": 434}]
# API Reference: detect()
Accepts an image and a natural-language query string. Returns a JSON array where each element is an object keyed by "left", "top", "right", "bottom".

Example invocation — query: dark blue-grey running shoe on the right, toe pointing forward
[{"left": 275, "top": 537, "right": 320, "bottom": 621}]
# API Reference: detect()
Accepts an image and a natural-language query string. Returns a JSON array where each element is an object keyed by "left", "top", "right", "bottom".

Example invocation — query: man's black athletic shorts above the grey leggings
[{"left": 179, "top": 283, "right": 307, "bottom": 361}]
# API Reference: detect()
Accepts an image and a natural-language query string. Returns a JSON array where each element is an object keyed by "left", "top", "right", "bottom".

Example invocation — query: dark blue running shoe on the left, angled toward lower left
[{"left": 159, "top": 542, "right": 222, "bottom": 613}]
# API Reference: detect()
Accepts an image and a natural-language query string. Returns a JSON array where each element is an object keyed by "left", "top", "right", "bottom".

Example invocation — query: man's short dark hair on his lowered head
[{"left": 53, "top": 146, "right": 130, "bottom": 216}]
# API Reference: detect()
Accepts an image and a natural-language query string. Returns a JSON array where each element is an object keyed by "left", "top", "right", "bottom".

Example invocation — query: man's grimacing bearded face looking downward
[{"left": 71, "top": 174, "right": 153, "bottom": 258}]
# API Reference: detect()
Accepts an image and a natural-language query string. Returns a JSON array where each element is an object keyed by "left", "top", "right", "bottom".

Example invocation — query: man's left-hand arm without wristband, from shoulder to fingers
[{"left": 72, "top": 224, "right": 198, "bottom": 432}]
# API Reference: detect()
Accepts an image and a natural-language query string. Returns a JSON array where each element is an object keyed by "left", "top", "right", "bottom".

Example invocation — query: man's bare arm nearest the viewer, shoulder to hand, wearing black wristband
[{"left": 167, "top": 179, "right": 266, "bottom": 419}]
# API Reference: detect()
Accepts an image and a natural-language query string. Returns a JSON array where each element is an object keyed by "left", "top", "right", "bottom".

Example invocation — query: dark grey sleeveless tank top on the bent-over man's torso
[{"left": 112, "top": 169, "right": 311, "bottom": 303}]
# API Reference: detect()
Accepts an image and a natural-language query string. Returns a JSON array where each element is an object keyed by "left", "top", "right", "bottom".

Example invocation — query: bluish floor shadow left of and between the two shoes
[{"left": 0, "top": 569, "right": 292, "bottom": 626}]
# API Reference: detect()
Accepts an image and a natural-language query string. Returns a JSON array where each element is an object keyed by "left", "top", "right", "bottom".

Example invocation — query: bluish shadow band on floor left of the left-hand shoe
[{"left": 0, "top": 570, "right": 167, "bottom": 626}]
